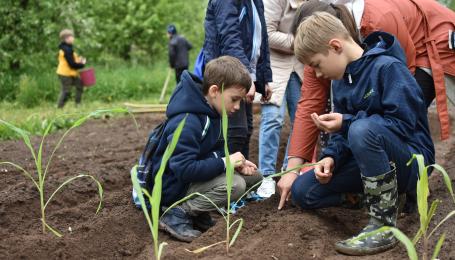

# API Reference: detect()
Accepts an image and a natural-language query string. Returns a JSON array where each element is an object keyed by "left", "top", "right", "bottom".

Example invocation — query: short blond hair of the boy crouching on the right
[{"left": 294, "top": 12, "right": 351, "bottom": 63}]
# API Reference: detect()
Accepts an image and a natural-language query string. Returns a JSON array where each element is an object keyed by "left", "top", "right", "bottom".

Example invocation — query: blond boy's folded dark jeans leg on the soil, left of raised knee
[{"left": 291, "top": 157, "right": 363, "bottom": 209}]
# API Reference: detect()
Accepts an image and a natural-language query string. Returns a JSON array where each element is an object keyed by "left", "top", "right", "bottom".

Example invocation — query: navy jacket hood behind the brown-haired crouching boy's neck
[{"left": 166, "top": 71, "right": 219, "bottom": 118}]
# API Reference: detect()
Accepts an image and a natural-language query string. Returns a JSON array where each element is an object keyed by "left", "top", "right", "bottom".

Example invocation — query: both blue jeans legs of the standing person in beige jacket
[{"left": 259, "top": 72, "right": 302, "bottom": 176}]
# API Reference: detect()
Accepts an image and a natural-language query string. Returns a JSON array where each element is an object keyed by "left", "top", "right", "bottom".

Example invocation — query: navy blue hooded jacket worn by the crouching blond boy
[{"left": 321, "top": 32, "right": 435, "bottom": 169}]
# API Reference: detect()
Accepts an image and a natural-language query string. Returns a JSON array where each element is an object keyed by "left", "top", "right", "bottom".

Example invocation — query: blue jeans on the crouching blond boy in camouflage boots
[{"left": 291, "top": 119, "right": 418, "bottom": 209}]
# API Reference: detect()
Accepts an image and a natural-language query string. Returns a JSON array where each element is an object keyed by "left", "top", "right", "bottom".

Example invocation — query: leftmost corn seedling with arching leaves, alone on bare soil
[{"left": 0, "top": 108, "right": 136, "bottom": 237}]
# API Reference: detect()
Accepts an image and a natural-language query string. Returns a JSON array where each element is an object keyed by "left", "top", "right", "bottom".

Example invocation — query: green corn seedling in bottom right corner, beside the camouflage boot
[{"left": 355, "top": 154, "right": 455, "bottom": 260}]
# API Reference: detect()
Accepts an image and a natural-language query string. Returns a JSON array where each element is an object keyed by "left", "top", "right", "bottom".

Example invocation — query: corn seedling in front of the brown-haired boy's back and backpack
[{"left": 131, "top": 117, "right": 186, "bottom": 260}]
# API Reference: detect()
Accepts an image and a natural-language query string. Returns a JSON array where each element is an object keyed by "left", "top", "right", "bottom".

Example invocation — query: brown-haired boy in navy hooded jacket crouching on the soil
[{"left": 147, "top": 56, "right": 262, "bottom": 242}]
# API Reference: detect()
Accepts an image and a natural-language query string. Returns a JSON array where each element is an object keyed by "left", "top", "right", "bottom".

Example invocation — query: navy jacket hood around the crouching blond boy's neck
[{"left": 343, "top": 32, "right": 406, "bottom": 84}]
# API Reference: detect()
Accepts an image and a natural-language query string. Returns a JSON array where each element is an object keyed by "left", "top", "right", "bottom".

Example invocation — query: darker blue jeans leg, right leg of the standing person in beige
[{"left": 283, "top": 71, "right": 302, "bottom": 169}]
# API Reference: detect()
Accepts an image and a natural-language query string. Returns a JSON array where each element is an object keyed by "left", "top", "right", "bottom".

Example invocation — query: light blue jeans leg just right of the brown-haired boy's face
[{"left": 259, "top": 104, "right": 284, "bottom": 176}]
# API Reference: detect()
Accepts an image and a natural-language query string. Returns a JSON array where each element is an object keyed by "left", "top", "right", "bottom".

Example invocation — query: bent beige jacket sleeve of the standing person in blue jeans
[{"left": 264, "top": 0, "right": 294, "bottom": 54}]
